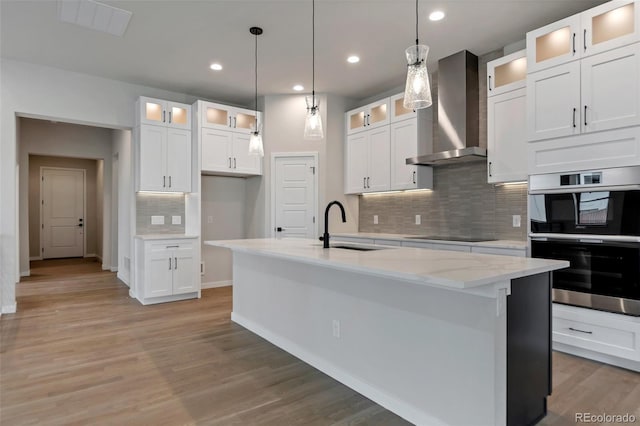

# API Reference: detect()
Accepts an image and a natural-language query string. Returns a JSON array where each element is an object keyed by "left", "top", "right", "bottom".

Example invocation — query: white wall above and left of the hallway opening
[{"left": 0, "top": 58, "right": 196, "bottom": 312}]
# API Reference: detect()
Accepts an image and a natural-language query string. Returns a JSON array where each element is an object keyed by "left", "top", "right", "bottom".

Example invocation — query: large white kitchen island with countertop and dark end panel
[{"left": 205, "top": 239, "right": 568, "bottom": 425}]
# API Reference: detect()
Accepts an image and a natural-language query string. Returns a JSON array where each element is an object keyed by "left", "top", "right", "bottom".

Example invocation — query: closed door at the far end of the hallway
[{"left": 41, "top": 168, "right": 85, "bottom": 259}]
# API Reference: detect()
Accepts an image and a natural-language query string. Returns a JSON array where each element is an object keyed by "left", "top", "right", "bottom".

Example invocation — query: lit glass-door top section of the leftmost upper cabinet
[{"left": 137, "top": 96, "right": 191, "bottom": 130}]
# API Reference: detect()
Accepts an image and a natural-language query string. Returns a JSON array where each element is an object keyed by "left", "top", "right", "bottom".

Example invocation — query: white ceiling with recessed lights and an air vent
[{"left": 0, "top": 0, "right": 604, "bottom": 105}]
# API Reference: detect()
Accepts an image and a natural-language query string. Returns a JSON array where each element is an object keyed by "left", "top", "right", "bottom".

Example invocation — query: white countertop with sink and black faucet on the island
[{"left": 204, "top": 239, "right": 569, "bottom": 289}]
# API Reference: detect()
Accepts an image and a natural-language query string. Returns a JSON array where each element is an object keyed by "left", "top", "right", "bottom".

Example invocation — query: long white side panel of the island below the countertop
[{"left": 232, "top": 251, "right": 506, "bottom": 426}]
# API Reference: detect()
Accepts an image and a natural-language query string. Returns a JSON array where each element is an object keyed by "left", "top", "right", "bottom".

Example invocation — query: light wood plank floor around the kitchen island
[{"left": 0, "top": 260, "right": 640, "bottom": 426}]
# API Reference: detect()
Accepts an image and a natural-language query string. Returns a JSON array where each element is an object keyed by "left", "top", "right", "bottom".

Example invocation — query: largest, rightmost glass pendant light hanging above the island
[{"left": 404, "top": 0, "right": 432, "bottom": 109}]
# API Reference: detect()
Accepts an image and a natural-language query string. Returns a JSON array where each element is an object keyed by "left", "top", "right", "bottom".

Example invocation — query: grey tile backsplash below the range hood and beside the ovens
[{"left": 358, "top": 161, "right": 528, "bottom": 241}]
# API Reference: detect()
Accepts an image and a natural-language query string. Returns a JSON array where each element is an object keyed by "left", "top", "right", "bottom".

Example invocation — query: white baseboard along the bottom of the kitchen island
[{"left": 231, "top": 312, "right": 436, "bottom": 425}]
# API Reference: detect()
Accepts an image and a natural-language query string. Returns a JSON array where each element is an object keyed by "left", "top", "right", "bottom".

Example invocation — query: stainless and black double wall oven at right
[{"left": 529, "top": 167, "right": 640, "bottom": 316}]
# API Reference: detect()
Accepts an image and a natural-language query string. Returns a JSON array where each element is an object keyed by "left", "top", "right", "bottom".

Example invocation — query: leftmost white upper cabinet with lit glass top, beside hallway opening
[{"left": 134, "top": 97, "right": 192, "bottom": 192}]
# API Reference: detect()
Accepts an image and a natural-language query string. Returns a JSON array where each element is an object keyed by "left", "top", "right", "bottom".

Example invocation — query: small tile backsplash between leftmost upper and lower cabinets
[{"left": 136, "top": 192, "right": 185, "bottom": 235}]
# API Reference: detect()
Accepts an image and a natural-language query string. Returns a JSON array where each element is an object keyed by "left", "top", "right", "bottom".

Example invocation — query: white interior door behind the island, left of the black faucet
[{"left": 273, "top": 156, "right": 317, "bottom": 238}]
